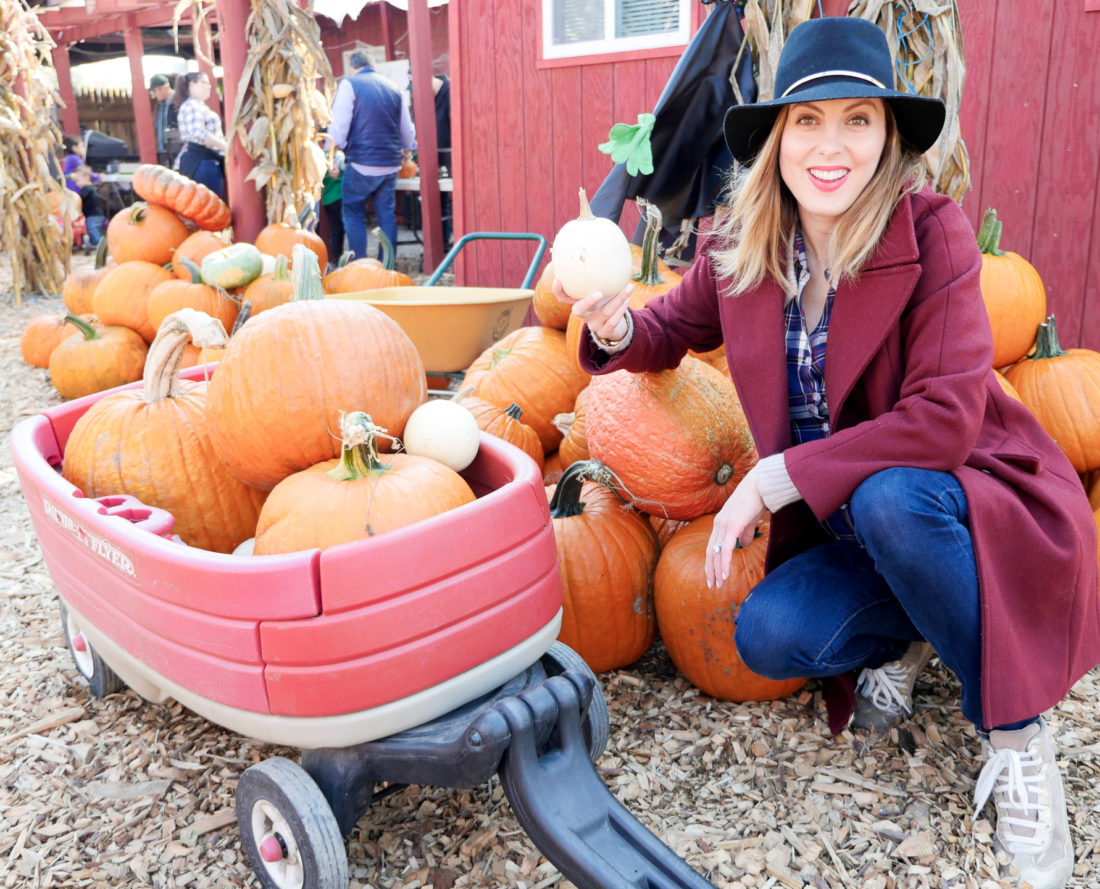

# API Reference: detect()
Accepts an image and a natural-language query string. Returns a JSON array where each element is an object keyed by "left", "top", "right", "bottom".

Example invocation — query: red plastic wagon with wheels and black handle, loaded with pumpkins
[{"left": 10, "top": 367, "right": 710, "bottom": 889}]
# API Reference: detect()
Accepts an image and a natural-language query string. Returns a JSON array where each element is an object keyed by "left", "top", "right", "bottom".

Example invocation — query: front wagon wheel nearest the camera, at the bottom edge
[{"left": 237, "top": 757, "right": 348, "bottom": 889}]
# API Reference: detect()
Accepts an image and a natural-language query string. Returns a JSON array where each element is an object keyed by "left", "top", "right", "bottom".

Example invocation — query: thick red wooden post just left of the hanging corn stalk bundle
[{"left": 218, "top": 0, "right": 267, "bottom": 243}]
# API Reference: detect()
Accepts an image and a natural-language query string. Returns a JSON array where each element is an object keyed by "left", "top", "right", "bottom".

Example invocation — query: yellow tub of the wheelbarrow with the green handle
[{"left": 326, "top": 286, "right": 535, "bottom": 374}]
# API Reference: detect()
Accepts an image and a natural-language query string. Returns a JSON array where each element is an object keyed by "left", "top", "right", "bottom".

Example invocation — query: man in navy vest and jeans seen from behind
[{"left": 329, "top": 50, "right": 416, "bottom": 260}]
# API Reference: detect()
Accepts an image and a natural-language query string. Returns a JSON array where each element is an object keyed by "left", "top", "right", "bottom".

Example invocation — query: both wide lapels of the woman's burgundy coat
[{"left": 722, "top": 195, "right": 921, "bottom": 456}]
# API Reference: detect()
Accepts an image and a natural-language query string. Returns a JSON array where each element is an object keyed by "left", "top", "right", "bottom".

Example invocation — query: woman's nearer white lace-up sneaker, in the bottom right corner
[{"left": 974, "top": 720, "right": 1074, "bottom": 889}]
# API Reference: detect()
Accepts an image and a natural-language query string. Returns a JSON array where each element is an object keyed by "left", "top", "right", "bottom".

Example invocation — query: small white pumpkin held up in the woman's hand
[{"left": 550, "top": 188, "right": 634, "bottom": 299}]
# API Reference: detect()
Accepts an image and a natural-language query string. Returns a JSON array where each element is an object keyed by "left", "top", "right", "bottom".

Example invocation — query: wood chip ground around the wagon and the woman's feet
[{"left": 0, "top": 251, "right": 1100, "bottom": 889}]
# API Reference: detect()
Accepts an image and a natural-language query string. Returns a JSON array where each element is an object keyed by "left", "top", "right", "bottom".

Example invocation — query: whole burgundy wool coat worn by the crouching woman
[{"left": 581, "top": 189, "right": 1100, "bottom": 726}]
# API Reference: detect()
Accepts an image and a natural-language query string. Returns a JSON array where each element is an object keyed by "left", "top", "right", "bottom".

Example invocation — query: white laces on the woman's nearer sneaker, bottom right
[{"left": 974, "top": 747, "right": 1053, "bottom": 855}]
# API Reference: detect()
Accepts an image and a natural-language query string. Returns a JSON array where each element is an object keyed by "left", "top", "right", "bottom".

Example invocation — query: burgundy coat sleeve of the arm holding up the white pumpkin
[{"left": 580, "top": 245, "right": 722, "bottom": 373}]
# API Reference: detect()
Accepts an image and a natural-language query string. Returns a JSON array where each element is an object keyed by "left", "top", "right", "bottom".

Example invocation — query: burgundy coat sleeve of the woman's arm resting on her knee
[{"left": 784, "top": 191, "right": 993, "bottom": 518}]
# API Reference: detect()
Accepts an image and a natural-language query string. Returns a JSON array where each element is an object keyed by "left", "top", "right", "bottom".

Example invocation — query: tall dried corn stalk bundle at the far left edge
[{"left": 0, "top": 0, "right": 73, "bottom": 305}]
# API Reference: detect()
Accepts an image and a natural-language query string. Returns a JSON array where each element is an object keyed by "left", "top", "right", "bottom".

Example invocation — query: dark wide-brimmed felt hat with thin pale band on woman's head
[{"left": 724, "top": 15, "right": 947, "bottom": 164}]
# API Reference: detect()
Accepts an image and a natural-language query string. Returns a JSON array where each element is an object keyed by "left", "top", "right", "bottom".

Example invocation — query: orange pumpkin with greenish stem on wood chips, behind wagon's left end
[{"left": 50, "top": 315, "right": 149, "bottom": 398}]
